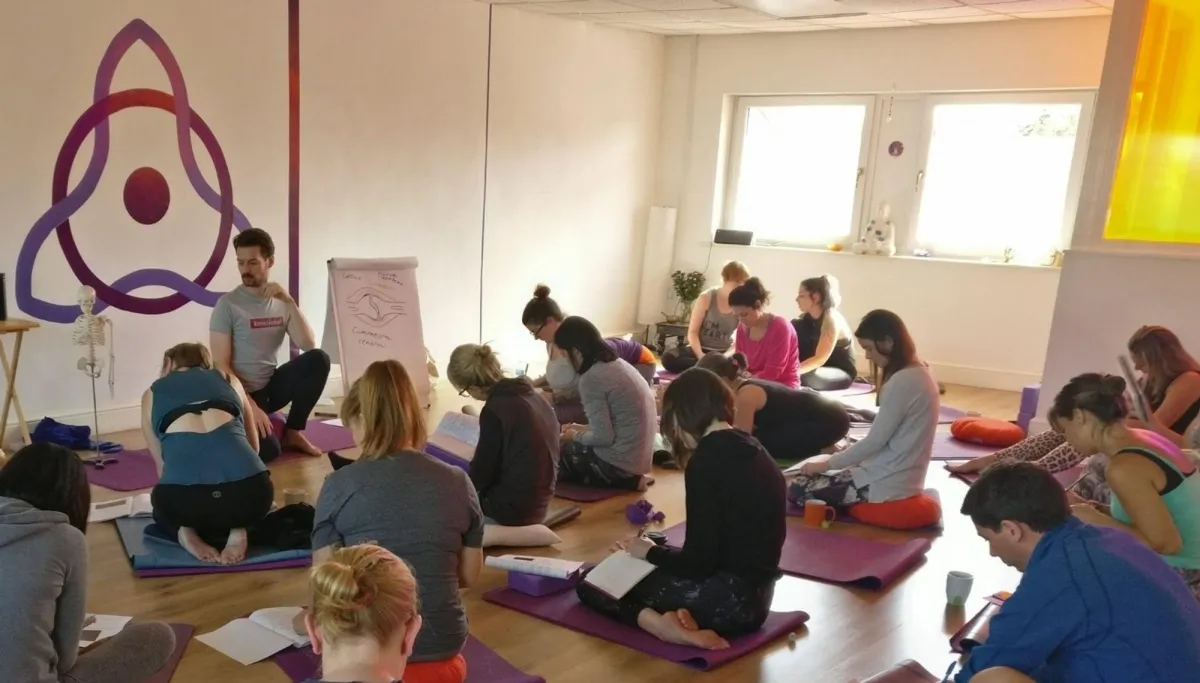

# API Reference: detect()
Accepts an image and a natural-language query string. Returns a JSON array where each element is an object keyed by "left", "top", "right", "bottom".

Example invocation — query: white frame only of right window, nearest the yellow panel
[{"left": 896, "top": 89, "right": 1096, "bottom": 260}]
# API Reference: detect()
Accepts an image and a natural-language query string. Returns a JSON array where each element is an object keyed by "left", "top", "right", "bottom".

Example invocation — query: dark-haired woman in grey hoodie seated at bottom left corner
[{"left": 0, "top": 443, "right": 175, "bottom": 683}]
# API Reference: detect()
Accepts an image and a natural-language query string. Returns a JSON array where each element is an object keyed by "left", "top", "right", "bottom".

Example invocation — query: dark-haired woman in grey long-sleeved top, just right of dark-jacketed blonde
[{"left": 554, "top": 316, "right": 659, "bottom": 490}]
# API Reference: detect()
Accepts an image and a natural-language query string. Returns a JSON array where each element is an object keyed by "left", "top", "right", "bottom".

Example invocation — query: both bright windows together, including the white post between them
[{"left": 722, "top": 91, "right": 1094, "bottom": 264}]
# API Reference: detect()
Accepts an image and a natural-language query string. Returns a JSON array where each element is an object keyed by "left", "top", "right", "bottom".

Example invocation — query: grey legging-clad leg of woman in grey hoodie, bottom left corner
[{"left": 59, "top": 622, "right": 175, "bottom": 683}]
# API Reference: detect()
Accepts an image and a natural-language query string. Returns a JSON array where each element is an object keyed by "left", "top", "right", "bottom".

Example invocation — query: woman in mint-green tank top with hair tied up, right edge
[{"left": 1049, "top": 373, "right": 1200, "bottom": 600}]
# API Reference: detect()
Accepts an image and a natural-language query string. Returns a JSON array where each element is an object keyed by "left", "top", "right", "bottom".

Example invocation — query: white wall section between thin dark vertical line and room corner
[{"left": 482, "top": 6, "right": 665, "bottom": 360}]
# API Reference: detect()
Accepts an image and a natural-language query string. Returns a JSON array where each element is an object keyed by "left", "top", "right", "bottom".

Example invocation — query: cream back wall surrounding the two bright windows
[{"left": 655, "top": 18, "right": 1108, "bottom": 389}]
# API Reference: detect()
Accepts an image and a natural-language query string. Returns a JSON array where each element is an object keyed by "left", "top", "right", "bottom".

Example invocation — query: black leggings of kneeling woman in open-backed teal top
[{"left": 150, "top": 472, "right": 275, "bottom": 545}]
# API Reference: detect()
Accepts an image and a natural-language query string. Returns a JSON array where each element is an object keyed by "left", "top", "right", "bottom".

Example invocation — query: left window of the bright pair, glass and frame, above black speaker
[{"left": 726, "top": 97, "right": 875, "bottom": 246}]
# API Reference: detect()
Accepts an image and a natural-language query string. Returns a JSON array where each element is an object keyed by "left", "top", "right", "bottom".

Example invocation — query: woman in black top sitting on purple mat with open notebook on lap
[{"left": 577, "top": 367, "right": 787, "bottom": 649}]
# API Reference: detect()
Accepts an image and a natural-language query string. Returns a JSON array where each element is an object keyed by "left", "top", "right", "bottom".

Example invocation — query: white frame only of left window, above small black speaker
[{"left": 720, "top": 94, "right": 880, "bottom": 248}]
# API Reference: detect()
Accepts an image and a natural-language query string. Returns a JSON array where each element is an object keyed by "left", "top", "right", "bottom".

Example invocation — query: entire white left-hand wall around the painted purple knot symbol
[{"left": 0, "top": 0, "right": 664, "bottom": 431}]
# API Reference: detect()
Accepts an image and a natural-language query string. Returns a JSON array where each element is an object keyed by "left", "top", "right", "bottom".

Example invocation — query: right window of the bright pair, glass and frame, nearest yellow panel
[{"left": 913, "top": 94, "right": 1091, "bottom": 263}]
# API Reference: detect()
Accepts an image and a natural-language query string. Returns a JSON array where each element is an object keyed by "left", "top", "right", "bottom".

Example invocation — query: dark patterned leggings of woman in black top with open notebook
[{"left": 575, "top": 569, "right": 775, "bottom": 637}]
